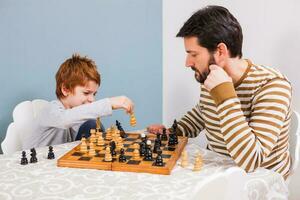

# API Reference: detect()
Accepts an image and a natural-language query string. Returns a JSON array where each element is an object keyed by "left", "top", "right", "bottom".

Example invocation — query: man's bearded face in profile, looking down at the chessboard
[{"left": 184, "top": 37, "right": 215, "bottom": 83}]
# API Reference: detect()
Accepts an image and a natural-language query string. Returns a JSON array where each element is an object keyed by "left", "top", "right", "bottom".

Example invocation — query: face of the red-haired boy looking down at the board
[{"left": 62, "top": 81, "right": 99, "bottom": 109}]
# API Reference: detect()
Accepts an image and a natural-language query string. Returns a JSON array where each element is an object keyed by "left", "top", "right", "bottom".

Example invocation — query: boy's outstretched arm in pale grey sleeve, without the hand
[{"left": 39, "top": 98, "right": 112, "bottom": 129}]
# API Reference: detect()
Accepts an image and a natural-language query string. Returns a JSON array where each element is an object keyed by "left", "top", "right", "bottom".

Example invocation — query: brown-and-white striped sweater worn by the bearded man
[{"left": 178, "top": 61, "right": 291, "bottom": 178}]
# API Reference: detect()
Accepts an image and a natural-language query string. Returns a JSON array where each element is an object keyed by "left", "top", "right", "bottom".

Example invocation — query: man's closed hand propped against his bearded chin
[{"left": 204, "top": 65, "right": 232, "bottom": 91}]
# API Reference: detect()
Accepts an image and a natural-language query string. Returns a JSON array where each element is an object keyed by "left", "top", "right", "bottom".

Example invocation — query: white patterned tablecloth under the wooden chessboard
[{"left": 0, "top": 139, "right": 288, "bottom": 200}]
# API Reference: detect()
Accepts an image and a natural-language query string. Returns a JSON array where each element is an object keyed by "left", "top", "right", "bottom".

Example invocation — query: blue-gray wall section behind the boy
[{"left": 0, "top": 0, "right": 162, "bottom": 153}]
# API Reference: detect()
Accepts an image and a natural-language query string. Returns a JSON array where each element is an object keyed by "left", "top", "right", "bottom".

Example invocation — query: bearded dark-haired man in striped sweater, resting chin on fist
[{"left": 148, "top": 6, "right": 291, "bottom": 178}]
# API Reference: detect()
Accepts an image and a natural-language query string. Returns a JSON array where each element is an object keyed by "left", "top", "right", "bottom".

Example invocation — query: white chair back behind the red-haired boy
[{"left": 1, "top": 99, "right": 49, "bottom": 154}]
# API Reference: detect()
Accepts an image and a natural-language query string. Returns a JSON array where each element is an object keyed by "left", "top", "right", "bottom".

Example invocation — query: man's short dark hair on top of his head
[{"left": 176, "top": 6, "right": 243, "bottom": 58}]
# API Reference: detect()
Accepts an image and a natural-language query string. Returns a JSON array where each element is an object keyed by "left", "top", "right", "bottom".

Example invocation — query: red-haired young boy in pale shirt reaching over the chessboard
[{"left": 23, "top": 54, "right": 134, "bottom": 149}]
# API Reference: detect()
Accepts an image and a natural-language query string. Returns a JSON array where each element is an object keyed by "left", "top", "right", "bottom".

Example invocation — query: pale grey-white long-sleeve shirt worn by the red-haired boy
[{"left": 23, "top": 98, "right": 112, "bottom": 149}]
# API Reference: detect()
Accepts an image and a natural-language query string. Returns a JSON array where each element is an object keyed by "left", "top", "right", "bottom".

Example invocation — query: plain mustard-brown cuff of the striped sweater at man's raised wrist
[{"left": 210, "top": 82, "right": 237, "bottom": 105}]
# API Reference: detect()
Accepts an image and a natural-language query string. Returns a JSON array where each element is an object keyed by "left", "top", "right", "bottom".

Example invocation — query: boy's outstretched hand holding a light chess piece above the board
[{"left": 109, "top": 96, "right": 134, "bottom": 114}]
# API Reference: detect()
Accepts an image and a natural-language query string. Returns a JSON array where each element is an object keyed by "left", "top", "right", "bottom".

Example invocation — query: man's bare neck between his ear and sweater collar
[{"left": 224, "top": 58, "right": 248, "bottom": 84}]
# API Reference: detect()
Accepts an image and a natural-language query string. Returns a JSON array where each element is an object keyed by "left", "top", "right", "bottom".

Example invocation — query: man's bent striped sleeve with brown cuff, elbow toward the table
[{"left": 211, "top": 78, "right": 291, "bottom": 172}]
